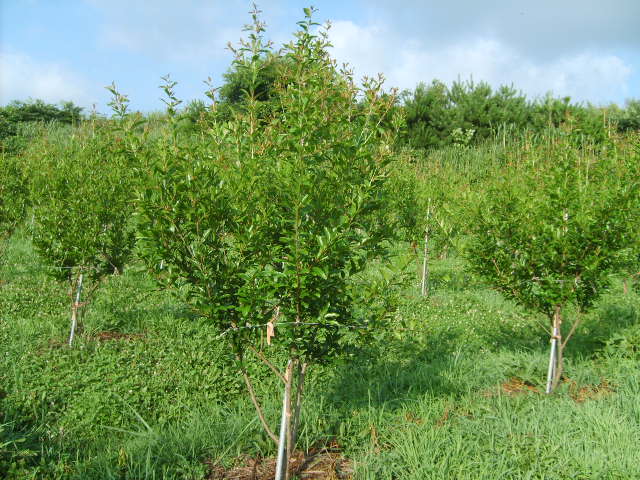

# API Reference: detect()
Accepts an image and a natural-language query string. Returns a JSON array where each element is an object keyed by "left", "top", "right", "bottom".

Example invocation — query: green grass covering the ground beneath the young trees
[{"left": 0, "top": 232, "right": 640, "bottom": 479}]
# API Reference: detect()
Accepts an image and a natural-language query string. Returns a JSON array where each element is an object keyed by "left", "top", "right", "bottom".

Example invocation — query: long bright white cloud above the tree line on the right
[{"left": 330, "top": 21, "right": 632, "bottom": 103}]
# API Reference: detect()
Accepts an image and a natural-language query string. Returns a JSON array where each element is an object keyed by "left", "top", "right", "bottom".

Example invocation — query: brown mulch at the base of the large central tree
[{"left": 205, "top": 448, "right": 353, "bottom": 480}]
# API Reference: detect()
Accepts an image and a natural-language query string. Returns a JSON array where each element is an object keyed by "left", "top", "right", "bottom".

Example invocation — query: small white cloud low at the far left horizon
[{"left": 0, "top": 51, "right": 92, "bottom": 106}]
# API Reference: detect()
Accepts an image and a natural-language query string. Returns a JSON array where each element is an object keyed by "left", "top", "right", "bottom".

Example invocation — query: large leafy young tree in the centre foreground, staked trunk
[{"left": 137, "top": 9, "right": 395, "bottom": 475}]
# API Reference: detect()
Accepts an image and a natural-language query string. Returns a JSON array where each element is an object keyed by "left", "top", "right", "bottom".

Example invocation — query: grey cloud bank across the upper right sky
[{"left": 362, "top": 0, "right": 640, "bottom": 58}]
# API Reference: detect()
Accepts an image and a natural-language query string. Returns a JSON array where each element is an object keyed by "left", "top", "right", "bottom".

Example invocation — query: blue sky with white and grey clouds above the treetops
[{"left": 0, "top": 0, "right": 640, "bottom": 113}]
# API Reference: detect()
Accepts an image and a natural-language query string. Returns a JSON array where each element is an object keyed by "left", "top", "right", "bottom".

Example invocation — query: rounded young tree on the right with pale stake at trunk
[{"left": 468, "top": 144, "right": 640, "bottom": 393}]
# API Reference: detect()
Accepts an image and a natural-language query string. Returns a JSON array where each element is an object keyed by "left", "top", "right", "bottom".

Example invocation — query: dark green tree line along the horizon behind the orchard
[{"left": 0, "top": 60, "right": 640, "bottom": 152}]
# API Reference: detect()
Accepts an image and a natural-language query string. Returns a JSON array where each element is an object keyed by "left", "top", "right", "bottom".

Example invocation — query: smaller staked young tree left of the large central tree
[{"left": 29, "top": 103, "right": 141, "bottom": 346}]
